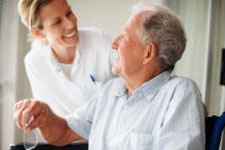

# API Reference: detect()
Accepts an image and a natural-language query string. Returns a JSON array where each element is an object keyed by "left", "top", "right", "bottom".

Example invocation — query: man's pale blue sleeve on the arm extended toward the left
[{"left": 65, "top": 94, "right": 98, "bottom": 140}]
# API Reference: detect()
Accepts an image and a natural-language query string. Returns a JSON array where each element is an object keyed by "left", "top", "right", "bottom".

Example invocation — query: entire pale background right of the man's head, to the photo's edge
[{"left": 168, "top": 0, "right": 225, "bottom": 115}]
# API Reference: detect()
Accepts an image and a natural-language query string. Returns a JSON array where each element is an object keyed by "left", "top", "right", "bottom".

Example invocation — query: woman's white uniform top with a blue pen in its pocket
[{"left": 24, "top": 28, "right": 114, "bottom": 116}]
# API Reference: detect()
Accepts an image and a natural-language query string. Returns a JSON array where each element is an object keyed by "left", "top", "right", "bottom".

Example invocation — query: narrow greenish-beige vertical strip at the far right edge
[{"left": 207, "top": 0, "right": 225, "bottom": 114}]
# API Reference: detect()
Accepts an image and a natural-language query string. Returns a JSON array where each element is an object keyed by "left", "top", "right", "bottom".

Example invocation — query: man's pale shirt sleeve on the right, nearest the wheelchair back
[{"left": 153, "top": 81, "right": 205, "bottom": 150}]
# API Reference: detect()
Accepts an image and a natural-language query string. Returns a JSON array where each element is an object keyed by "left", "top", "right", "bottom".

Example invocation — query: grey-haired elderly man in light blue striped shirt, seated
[{"left": 15, "top": 6, "right": 205, "bottom": 150}]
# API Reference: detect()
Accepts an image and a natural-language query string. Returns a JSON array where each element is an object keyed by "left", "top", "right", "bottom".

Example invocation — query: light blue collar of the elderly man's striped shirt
[{"left": 115, "top": 71, "right": 171, "bottom": 100}]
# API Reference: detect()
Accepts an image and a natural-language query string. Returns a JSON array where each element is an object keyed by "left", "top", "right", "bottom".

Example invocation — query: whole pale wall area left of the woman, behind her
[{"left": 0, "top": 0, "right": 31, "bottom": 150}]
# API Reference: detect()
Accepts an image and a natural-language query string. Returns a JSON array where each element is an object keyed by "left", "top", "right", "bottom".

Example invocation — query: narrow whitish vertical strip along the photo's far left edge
[{"left": 0, "top": 1, "right": 18, "bottom": 150}]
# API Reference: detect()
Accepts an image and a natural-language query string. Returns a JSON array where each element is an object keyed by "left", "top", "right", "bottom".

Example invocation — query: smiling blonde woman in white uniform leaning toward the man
[{"left": 18, "top": 0, "right": 113, "bottom": 116}]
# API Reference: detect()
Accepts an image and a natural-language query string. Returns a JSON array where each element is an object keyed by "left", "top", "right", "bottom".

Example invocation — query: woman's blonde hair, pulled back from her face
[{"left": 18, "top": 0, "right": 52, "bottom": 29}]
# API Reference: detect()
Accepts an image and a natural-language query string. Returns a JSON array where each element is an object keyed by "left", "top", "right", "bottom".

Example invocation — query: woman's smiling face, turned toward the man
[{"left": 37, "top": 0, "right": 79, "bottom": 49}]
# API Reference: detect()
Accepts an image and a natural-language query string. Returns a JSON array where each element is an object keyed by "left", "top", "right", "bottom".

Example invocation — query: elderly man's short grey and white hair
[{"left": 132, "top": 3, "right": 186, "bottom": 70}]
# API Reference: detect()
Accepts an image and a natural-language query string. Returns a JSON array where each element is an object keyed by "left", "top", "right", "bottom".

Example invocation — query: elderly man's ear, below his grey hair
[{"left": 143, "top": 42, "right": 157, "bottom": 64}]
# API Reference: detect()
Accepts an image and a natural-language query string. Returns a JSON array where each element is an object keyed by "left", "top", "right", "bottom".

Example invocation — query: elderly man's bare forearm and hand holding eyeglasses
[{"left": 14, "top": 99, "right": 82, "bottom": 146}]
